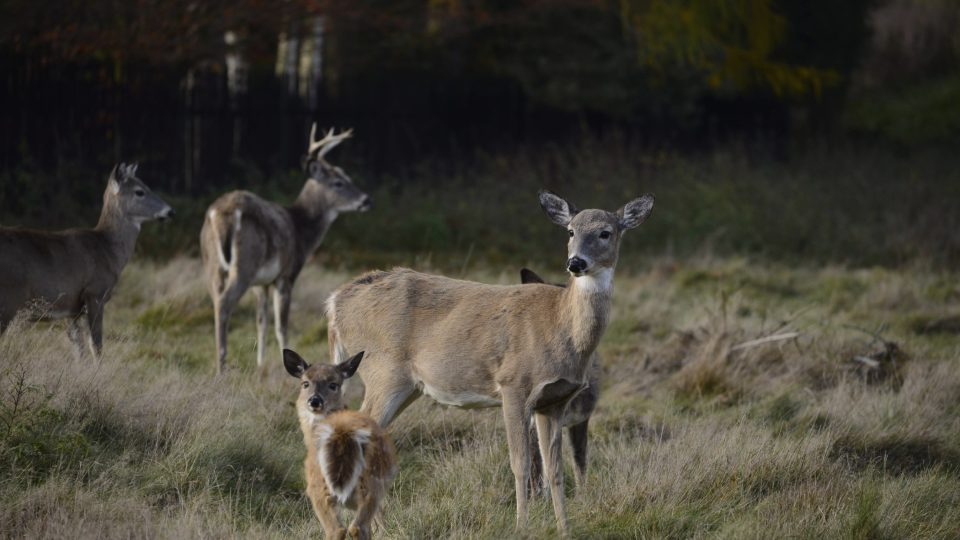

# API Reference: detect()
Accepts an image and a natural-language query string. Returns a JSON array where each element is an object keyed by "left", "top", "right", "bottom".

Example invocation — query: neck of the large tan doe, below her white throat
[{"left": 563, "top": 268, "right": 613, "bottom": 357}]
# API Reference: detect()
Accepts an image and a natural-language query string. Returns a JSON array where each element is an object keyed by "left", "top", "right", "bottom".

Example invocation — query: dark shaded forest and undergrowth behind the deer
[{"left": 0, "top": 0, "right": 960, "bottom": 267}]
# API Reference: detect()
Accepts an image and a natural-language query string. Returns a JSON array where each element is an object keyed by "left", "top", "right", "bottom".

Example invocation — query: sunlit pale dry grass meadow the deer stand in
[{"left": 0, "top": 256, "right": 960, "bottom": 539}]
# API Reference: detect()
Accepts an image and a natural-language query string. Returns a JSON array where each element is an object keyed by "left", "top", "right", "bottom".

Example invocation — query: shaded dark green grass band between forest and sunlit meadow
[{"left": 0, "top": 140, "right": 960, "bottom": 272}]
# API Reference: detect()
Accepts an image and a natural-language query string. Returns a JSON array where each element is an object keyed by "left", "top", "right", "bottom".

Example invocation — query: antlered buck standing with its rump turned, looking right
[{"left": 200, "top": 124, "right": 370, "bottom": 374}]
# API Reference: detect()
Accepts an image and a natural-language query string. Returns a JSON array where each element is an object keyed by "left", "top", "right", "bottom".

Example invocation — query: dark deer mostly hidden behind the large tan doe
[{"left": 520, "top": 268, "right": 600, "bottom": 493}]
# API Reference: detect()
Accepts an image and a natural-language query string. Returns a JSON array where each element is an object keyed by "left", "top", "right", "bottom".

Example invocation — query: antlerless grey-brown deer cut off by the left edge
[{"left": 0, "top": 163, "right": 173, "bottom": 358}]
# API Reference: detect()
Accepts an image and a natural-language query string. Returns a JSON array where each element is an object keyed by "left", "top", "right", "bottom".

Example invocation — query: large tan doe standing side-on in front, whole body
[{"left": 327, "top": 192, "right": 653, "bottom": 533}]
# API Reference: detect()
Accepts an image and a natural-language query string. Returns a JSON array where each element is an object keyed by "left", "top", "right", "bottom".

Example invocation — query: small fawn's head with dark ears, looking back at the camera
[{"left": 283, "top": 349, "right": 363, "bottom": 416}]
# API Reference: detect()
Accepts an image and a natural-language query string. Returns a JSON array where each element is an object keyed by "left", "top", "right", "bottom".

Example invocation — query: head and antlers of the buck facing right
[{"left": 301, "top": 124, "right": 371, "bottom": 212}]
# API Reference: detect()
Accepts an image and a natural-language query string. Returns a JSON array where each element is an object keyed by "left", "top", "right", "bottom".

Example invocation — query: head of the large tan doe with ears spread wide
[{"left": 540, "top": 191, "right": 653, "bottom": 277}]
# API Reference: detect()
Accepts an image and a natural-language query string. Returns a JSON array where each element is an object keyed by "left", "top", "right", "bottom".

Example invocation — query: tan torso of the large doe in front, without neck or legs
[{"left": 327, "top": 269, "right": 577, "bottom": 390}]
